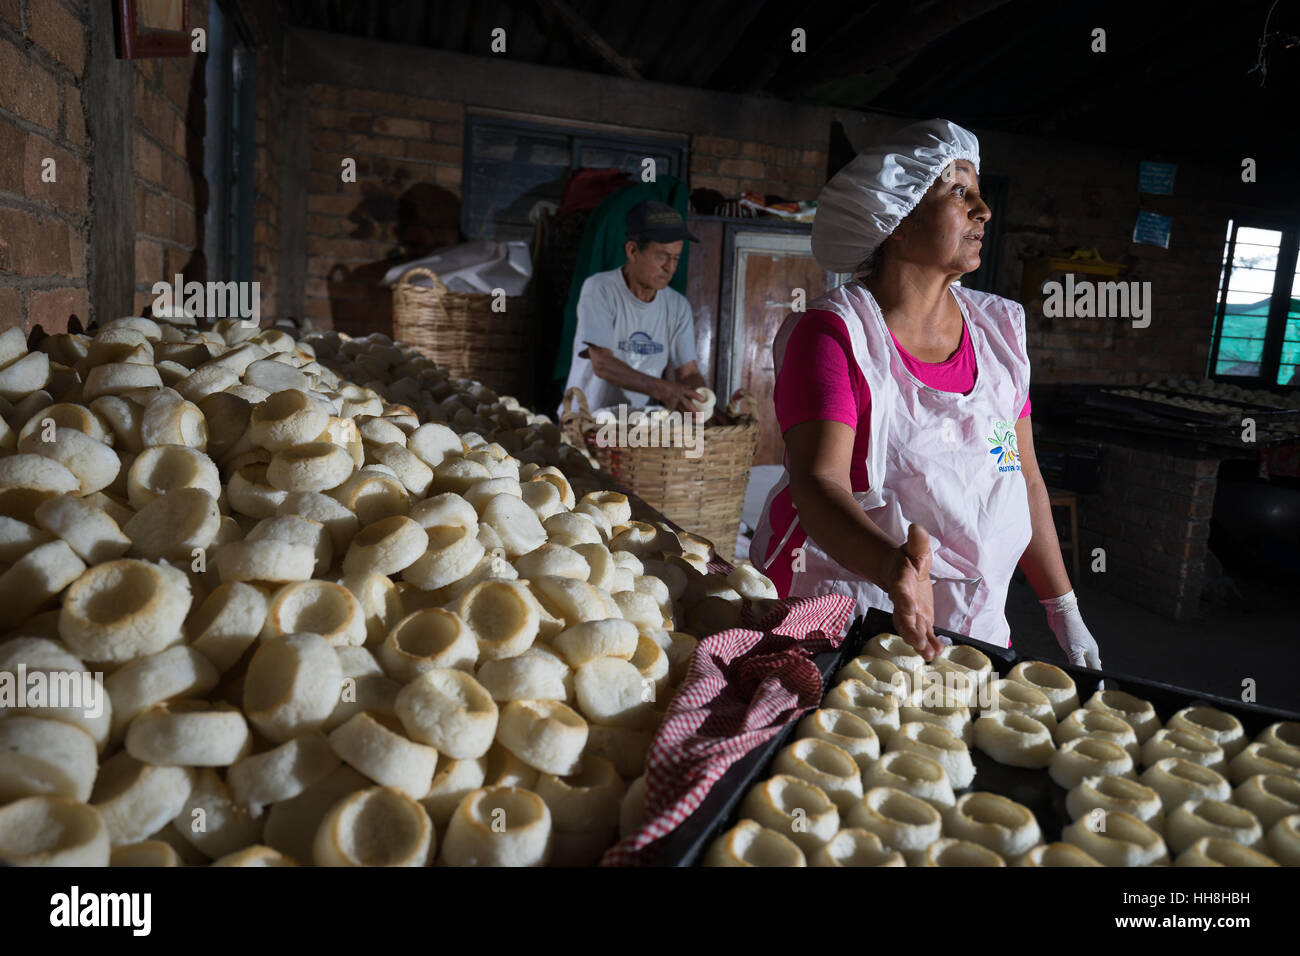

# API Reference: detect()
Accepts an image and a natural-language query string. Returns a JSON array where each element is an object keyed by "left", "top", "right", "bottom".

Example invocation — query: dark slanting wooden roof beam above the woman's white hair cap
[{"left": 774, "top": 0, "right": 1008, "bottom": 95}]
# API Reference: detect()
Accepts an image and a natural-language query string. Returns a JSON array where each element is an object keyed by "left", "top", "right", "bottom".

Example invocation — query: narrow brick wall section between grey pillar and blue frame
[{"left": 131, "top": 0, "right": 208, "bottom": 313}]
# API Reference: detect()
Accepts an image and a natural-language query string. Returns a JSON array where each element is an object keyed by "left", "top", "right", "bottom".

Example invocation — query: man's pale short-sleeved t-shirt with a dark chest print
[{"left": 564, "top": 267, "right": 697, "bottom": 411}]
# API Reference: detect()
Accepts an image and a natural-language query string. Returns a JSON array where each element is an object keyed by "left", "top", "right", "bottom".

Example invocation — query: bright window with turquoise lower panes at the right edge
[{"left": 1209, "top": 220, "right": 1300, "bottom": 385}]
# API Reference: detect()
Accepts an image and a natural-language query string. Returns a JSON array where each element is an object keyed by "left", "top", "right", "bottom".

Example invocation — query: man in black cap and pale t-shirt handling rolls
[{"left": 564, "top": 200, "right": 707, "bottom": 412}]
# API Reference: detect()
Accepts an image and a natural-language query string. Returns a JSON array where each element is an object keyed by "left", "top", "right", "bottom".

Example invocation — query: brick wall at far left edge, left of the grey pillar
[{"left": 0, "top": 0, "right": 90, "bottom": 332}]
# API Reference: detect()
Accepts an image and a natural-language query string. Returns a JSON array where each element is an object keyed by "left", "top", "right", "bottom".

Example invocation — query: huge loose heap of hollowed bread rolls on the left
[{"left": 0, "top": 317, "right": 775, "bottom": 866}]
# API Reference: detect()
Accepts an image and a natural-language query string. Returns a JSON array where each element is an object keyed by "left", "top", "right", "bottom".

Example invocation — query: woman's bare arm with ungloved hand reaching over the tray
[{"left": 775, "top": 421, "right": 943, "bottom": 661}]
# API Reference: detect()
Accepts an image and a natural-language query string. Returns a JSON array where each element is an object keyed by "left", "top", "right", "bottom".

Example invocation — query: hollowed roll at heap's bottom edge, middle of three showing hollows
[{"left": 312, "top": 787, "right": 437, "bottom": 866}]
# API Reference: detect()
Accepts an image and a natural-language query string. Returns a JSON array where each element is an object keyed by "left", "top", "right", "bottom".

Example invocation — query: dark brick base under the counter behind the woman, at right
[{"left": 1079, "top": 444, "right": 1218, "bottom": 620}]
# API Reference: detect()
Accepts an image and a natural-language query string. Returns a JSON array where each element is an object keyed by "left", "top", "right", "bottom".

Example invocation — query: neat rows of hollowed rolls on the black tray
[{"left": 705, "top": 635, "right": 1300, "bottom": 866}]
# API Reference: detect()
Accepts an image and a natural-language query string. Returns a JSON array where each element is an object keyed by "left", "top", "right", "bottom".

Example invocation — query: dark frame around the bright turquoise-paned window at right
[{"left": 1205, "top": 213, "right": 1300, "bottom": 390}]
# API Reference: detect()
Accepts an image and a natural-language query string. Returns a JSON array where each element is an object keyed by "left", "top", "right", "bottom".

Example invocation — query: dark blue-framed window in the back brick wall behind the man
[{"left": 460, "top": 116, "right": 686, "bottom": 241}]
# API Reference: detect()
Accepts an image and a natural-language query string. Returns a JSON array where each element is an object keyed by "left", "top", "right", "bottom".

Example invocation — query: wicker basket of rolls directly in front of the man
[{"left": 560, "top": 388, "right": 758, "bottom": 562}]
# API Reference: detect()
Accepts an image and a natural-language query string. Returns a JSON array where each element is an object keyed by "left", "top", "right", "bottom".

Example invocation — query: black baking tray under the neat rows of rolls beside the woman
[{"left": 647, "top": 607, "right": 1300, "bottom": 866}]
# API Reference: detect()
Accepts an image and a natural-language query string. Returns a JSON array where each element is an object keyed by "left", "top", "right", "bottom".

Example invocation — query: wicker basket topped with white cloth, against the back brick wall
[{"left": 393, "top": 267, "right": 533, "bottom": 401}]
